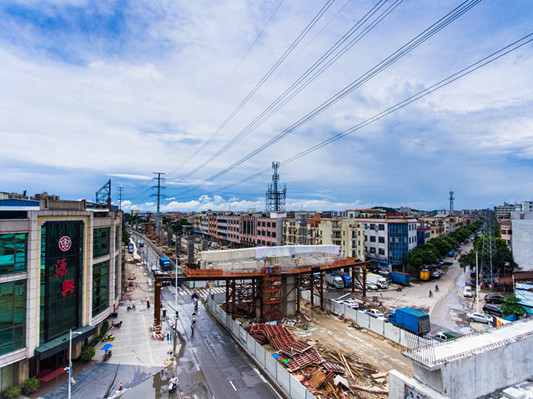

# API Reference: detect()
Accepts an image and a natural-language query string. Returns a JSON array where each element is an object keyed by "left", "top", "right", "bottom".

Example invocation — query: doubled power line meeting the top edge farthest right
[{"left": 174, "top": 0, "right": 481, "bottom": 196}]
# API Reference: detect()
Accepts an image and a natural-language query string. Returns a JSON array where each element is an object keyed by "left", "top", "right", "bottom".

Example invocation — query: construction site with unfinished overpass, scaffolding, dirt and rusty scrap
[{"left": 123, "top": 228, "right": 412, "bottom": 398}]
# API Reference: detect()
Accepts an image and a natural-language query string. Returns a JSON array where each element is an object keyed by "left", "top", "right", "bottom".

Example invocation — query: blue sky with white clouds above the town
[{"left": 0, "top": 0, "right": 533, "bottom": 212}]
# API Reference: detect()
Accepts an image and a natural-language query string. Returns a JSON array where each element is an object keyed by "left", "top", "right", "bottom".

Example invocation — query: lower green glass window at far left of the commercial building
[{"left": 0, "top": 280, "right": 26, "bottom": 355}]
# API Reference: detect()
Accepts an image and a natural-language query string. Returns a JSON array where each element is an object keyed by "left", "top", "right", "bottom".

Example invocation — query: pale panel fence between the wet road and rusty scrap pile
[{"left": 206, "top": 297, "right": 315, "bottom": 399}]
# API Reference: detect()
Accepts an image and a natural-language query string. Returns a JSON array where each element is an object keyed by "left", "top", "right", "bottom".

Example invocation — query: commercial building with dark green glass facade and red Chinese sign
[{"left": 0, "top": 199, "right": 122, "bottom": 392}]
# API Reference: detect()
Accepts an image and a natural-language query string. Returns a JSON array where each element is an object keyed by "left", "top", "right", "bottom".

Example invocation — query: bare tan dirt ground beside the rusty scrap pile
[{"left": 276, "top": 306, "right": 413, "bottom": 399}]
